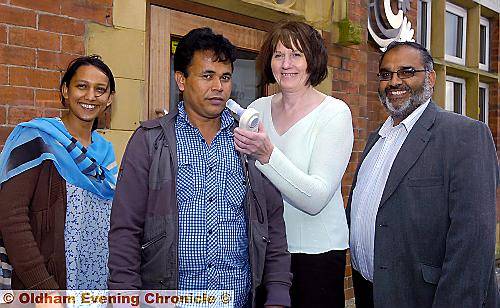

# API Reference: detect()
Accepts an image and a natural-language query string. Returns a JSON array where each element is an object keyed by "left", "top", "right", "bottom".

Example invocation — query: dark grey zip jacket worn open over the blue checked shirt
[{"left": 108, "top": 110, "right": 292, "bottom": 307}]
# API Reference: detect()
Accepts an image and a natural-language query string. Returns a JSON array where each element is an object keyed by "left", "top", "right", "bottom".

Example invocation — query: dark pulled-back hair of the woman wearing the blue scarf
[{"left": 59, "top": 55, "right": 116, "bottom": 106}]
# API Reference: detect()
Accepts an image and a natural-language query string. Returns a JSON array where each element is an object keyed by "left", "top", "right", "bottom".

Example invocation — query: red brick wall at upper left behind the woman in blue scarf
[{"left": 0, "top": 0, "right": 113, "bottom": 150}]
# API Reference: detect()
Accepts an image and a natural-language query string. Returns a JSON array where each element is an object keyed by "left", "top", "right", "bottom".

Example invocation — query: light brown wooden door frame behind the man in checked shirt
[{"left": 143, "top": 5, "right": 266, "bottom": 119}]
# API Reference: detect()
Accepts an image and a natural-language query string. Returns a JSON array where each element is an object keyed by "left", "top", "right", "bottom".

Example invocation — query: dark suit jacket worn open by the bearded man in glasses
[{"left": 346, "top": 102, "right": 500, "bottom": 308}]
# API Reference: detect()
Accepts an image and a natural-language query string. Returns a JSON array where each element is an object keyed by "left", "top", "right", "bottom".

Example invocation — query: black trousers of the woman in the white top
[{"left": 290, "top": 250, "right": 346, "bottom": 308}]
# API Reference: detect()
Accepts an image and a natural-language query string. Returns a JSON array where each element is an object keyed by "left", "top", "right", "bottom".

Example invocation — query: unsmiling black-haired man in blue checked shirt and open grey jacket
[{"left": 109, "top": 28, "right": 291, "bottom": 307}]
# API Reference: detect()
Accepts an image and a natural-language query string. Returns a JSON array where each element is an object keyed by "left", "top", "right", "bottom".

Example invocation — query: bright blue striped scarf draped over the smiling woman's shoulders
[{"left": 0, "top": 118, "right": 118, "bottom": 200}]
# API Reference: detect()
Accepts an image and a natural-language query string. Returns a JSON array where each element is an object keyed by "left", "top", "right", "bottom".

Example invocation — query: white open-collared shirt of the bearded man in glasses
[{"left": 350, "top": 101, "right": 429, "bottom": 281}]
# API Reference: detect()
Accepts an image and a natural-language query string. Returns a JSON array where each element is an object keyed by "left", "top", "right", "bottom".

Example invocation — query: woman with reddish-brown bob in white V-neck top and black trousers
[{"left": 234, "top": 22, "right": 353, "bottom": 308}]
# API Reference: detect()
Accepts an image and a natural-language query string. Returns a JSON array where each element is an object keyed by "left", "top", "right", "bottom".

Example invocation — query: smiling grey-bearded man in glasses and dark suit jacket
[{"left": 346, "top": 42, "right": 500, "bottom": 308}]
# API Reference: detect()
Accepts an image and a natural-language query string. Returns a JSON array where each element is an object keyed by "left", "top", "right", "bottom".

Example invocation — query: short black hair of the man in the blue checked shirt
[{"left": 174, "top": 27, "right": 236, "bottom": 77}]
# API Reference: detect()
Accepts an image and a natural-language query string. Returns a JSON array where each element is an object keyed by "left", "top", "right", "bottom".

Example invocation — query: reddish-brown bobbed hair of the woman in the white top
[{"left": 257, "top": 21, "right": 328, "bottom": 86}]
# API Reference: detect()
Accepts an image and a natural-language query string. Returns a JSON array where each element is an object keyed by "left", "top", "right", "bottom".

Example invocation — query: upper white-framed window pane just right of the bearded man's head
[{"left": 445, "top": 3, "right": 467, "bottom": 65}]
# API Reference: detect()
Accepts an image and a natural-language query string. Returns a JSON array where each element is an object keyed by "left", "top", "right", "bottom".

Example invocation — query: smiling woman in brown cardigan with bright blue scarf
[{"left": 0, "top": 56, "right": 118, "bottom": 290}]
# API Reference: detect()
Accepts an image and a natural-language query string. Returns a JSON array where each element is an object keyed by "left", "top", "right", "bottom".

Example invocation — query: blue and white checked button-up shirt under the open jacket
[{"left": 175, "top": 102, "right": 251, "bottom": 307}]
